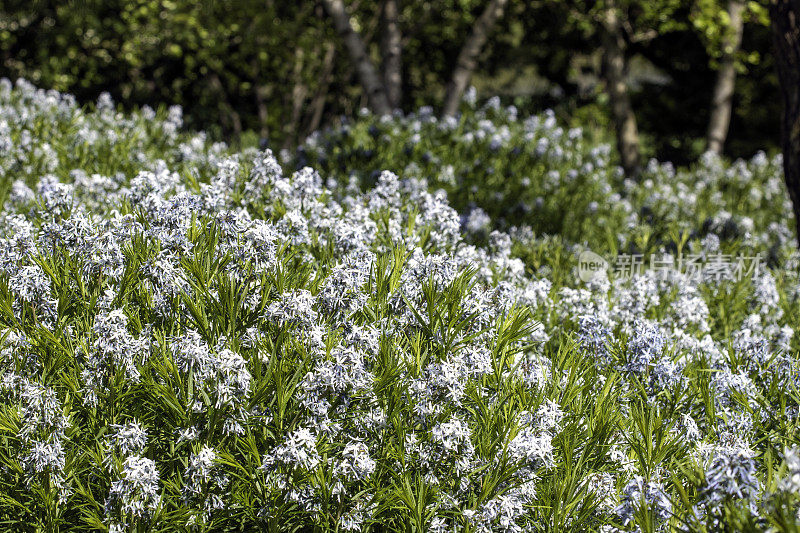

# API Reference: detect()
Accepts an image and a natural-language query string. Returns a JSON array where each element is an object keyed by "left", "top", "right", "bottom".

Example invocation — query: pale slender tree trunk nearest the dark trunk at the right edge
[{"left": 706, "top": 0, "right": 744, "bottom": 154}]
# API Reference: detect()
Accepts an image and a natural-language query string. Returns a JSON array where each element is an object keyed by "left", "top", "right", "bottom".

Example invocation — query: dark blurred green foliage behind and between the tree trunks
[{"left": 0, "top": 0, "right": 780, "bottom": 164}]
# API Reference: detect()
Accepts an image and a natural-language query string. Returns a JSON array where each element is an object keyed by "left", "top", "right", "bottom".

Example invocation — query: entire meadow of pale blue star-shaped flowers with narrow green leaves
[{"left": 0, "top": 80, "right": 800, "bottom": 533}]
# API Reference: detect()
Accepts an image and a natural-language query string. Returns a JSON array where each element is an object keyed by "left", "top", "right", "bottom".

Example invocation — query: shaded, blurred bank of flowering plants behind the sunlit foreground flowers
[{"left": 296, "top": 93, "right": 792, "bottom": 260}]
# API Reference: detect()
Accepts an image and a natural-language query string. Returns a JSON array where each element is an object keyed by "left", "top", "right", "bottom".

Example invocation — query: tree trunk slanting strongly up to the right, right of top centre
[{"left": 442, "top": 0, "right": 508, "bottom": 117}]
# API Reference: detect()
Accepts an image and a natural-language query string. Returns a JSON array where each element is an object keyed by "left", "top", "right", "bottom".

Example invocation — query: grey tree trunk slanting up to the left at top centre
[{"left": 322, "top": 0, "right": 392, "bottom": 115}]
